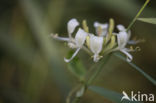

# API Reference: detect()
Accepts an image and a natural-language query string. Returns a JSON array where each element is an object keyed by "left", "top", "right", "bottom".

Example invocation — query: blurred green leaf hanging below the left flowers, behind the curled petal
[{"left": 68, "top": 51, "right": 86, "bottom": 79}]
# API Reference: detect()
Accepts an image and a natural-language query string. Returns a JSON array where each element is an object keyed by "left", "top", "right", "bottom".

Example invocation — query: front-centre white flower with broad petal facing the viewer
[{"left": 90, "top": 34, "right": 103, "bottom": 62}]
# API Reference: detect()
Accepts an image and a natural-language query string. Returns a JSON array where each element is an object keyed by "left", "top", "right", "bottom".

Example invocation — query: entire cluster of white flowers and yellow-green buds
[{"left": 52, "top": 18, "right": 138, "bottom": 62}]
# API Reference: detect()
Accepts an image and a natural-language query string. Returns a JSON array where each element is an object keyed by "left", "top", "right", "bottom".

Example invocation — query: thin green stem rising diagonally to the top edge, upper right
[{"left": 126, "top": 0, "right": 150, "bottom": 31}]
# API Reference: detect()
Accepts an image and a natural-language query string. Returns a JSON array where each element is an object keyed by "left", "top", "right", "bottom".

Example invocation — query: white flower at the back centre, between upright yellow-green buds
[{"left": 94, "top": 22, "right": 108, "bottom": 36}]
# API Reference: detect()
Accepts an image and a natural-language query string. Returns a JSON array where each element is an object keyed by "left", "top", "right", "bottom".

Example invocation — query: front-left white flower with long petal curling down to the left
[{"left": 64, "top": 28, "right": 88, "bottom": 62}]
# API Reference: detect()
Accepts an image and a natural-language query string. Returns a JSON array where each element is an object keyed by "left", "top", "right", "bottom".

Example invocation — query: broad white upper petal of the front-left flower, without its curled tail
[{"left": 75, "top": 28, "right": 88, "bottom": 47}]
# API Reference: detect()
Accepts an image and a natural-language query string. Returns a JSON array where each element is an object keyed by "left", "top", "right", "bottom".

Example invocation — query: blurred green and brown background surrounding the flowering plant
[{"left": 0, "top": 0, "right": 156, "bottom": 103}]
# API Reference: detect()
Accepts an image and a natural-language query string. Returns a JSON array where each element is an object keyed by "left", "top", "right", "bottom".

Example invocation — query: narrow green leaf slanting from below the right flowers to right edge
[{"left": 114, "top": 53, "right": 156, "bottom": 85}]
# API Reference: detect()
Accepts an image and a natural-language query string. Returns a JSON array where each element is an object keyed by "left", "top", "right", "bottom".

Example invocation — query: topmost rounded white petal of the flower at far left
[{"left": 67, "top": 18, "right": 79, "bottom": 37}]
